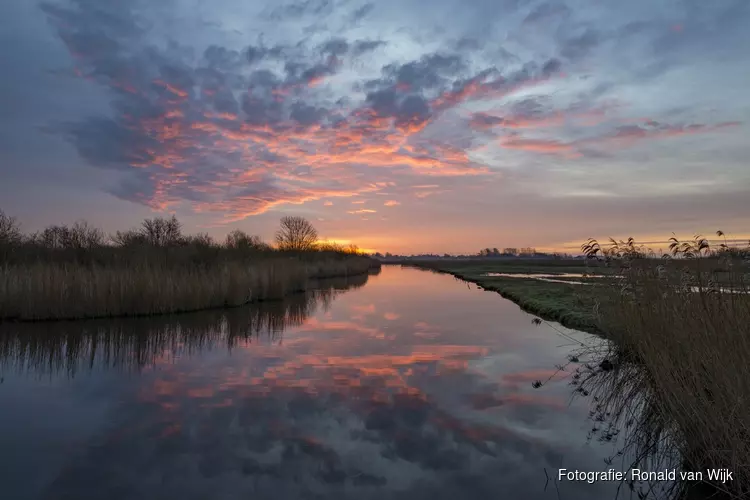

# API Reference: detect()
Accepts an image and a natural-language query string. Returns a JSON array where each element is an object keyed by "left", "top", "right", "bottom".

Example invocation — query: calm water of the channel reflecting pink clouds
[{"left": 0, "top": 267, "right": 616, "bottom": 500}]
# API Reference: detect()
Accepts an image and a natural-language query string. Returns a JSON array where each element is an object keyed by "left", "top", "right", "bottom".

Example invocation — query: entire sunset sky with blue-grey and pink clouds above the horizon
[{"left": 0, "top": 0, "right": 750, "bottom": 253}]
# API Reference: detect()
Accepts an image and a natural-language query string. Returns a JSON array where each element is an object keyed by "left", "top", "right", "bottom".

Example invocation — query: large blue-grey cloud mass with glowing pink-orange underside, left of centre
[{"left": 41, "top": 1, "right": 516, "bottom": 220}]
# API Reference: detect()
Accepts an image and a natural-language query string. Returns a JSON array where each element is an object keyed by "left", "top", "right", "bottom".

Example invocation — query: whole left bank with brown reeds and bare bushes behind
[{"left": 0, "top": 212, "right": 380, "bottom": 321}]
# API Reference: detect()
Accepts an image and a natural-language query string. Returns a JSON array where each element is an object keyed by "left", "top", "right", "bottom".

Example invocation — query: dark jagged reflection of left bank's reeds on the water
[{"left": 0, "top": 274, "right": 367, "bottom": 376}]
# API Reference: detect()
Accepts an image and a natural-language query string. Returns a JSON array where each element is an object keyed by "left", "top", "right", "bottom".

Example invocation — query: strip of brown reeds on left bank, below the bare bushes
[{"left": 0, "top": 256, "right": 373, "bottom": 320}]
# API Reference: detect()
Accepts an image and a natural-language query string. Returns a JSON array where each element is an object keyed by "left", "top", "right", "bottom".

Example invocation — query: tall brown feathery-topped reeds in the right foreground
[{"left": 584, "top": 237, "right": 750, "bottom": 498}]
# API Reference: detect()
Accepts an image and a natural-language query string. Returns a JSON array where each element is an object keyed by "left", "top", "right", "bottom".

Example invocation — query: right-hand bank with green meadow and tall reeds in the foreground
[{"left": 406, "top": 238, "right": 750, "bottom": 498}]
